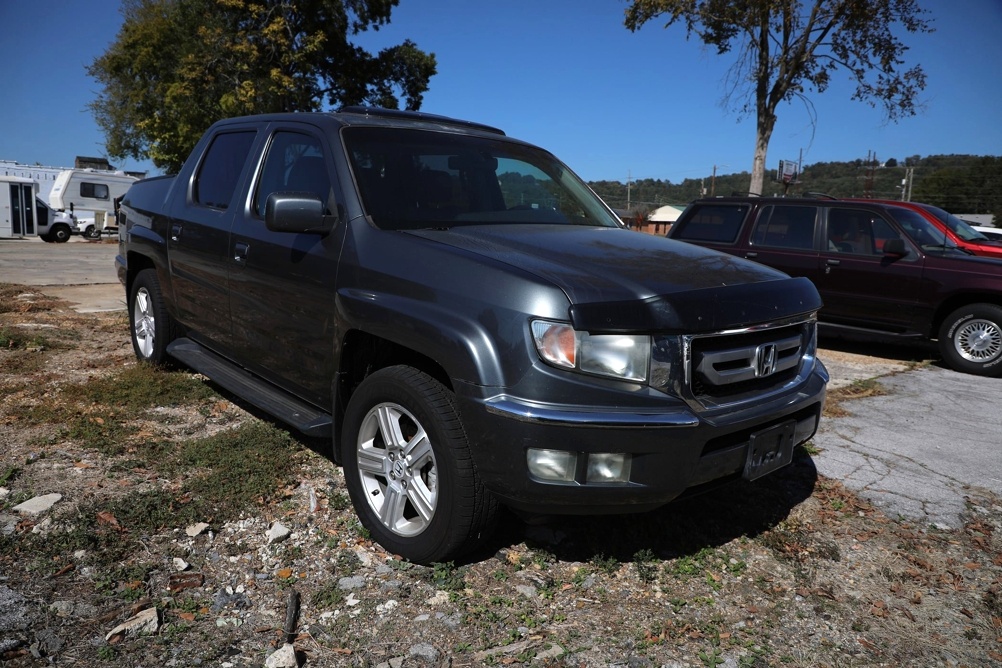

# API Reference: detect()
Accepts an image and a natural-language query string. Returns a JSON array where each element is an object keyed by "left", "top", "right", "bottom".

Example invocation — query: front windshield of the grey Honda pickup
[{"left": 344, "top": 127, "right": 621, "bottom": 229}]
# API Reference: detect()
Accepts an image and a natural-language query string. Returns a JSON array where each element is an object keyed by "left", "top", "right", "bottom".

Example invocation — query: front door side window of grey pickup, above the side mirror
[{"left": 255, "top": 131, "right": 331, "bottom": 216}]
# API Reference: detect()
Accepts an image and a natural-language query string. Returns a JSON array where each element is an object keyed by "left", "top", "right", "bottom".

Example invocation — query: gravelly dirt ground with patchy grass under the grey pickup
[{"left": 0, "top": 285, "right": 1002, "bottom": 667}]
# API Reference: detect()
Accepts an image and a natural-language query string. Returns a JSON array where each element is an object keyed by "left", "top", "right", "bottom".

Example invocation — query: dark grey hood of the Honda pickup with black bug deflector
[{"left": 408, "top": 224, "right": 822, "bottom": 331}]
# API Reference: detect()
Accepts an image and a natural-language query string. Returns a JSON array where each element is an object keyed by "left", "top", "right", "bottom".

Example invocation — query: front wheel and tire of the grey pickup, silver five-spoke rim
[{"left": 342, "top": 367, "right": 497, "bottom": 564}]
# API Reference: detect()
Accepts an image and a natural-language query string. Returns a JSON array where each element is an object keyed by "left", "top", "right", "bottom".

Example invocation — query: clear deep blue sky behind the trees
[{"left": 0, "top": 0, "right": 1002, "bottom": 183}]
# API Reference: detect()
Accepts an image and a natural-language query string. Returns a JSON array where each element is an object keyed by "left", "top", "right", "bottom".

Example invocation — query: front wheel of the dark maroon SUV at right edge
[{"left": 939, "top": 303, "right": 1002, "bottom": 378}]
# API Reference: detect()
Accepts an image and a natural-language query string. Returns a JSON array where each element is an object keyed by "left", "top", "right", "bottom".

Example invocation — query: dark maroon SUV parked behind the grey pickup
[{"left": 668, "top": 197, "right": 1002, "bottom": 377}]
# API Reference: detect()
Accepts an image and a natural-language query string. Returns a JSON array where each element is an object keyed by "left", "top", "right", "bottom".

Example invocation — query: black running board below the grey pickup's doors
[{"left": 167, "top": 339, "right": 334, "bottom": 438}]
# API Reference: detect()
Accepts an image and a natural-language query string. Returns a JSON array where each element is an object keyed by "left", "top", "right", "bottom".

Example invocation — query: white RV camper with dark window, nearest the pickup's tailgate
[{"left": 49, "top": 169, "right": 139, "bottom": 236}]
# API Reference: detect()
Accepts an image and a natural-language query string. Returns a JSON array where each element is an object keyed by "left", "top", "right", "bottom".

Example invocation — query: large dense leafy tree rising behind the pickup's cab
[{"left": 87, "top": 0, "right": 436, "bottom": 172}]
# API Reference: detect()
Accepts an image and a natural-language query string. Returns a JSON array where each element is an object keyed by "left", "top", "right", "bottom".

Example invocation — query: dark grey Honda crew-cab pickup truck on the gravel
[{"left": 115, "top": 107, "right": 828, "bottom": 563}]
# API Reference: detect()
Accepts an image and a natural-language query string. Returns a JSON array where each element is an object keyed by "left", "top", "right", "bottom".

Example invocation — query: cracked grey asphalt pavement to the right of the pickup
[{"left": 813, "top": 362, "right": 1002, "bottom": 528}]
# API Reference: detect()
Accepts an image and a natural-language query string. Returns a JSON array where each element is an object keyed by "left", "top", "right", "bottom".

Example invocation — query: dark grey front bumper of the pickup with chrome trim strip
[{"left": 457, "top": 362, "right": 829, "bottom": 515}]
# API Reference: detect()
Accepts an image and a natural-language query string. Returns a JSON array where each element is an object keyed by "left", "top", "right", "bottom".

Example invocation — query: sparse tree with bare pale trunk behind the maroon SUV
[{"left": 625, "top": 0, "right": 932, "bottom": 193}]
